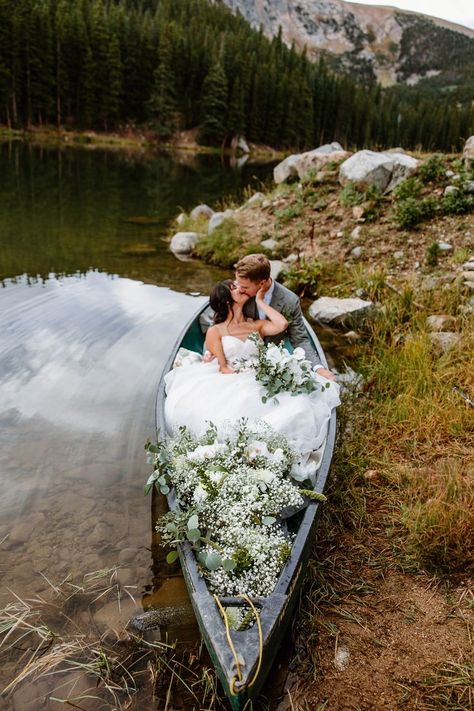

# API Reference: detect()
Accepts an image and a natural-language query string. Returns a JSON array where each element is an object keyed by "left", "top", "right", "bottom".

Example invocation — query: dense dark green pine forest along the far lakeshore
[{"left": 0, "top": 0, "right": 474, "bottom": 151}]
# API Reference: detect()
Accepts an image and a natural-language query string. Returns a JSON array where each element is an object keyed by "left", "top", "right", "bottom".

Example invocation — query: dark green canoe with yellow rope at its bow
[{"left": 156, "top": 298, "right": 336, "bottom": 711}]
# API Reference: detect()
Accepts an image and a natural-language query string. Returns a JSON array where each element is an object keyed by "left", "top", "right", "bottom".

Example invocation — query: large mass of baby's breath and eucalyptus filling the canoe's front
[{"left": 145, "top": 420, "right": 324, "bottom": 597}]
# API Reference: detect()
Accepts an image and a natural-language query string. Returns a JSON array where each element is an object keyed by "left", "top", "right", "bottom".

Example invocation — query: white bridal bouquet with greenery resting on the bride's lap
[{"left": 235, "top": 333, "right": 330, "bottom": 402}]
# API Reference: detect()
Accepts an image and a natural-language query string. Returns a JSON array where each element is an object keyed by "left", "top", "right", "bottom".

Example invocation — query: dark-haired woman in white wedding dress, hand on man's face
[{"left": 165, "top": 279, "right": 340, "bottom": 476}]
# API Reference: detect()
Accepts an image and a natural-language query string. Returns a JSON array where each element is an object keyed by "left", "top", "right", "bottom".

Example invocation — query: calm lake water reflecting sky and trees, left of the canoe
[{"left": 0, "top": 143, "right": 278, "bottom": 710}]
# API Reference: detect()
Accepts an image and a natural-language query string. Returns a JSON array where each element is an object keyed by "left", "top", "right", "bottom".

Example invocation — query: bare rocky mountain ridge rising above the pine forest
[{"left": 222, "top": 0, "right": 474, "bottom": 86}]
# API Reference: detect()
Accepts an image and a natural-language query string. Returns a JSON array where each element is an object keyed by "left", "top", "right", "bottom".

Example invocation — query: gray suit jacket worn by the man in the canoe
[{"left": 244, "top": 282, "right": 321, "bottom": 366}]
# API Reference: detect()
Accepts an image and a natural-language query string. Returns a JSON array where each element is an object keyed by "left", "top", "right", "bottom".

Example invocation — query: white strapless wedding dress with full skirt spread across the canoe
[{"left": 165, "top": 335, "right": 340, "bottom": 476}]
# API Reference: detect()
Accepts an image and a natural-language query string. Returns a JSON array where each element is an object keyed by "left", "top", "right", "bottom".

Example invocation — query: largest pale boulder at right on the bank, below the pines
[{"left": 339, "top": 150, "right": 419, "bottom": 192}]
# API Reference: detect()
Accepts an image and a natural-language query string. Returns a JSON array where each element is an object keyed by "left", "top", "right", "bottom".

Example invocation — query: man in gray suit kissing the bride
[{"left": 235, "top": 254, "right": 336, "bottom": 380}]
